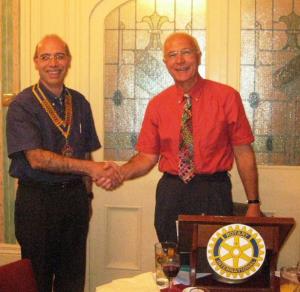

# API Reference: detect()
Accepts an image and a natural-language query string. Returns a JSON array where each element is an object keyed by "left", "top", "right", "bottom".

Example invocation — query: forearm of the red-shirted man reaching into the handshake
[{"left": 121, "top": 152, "right": 158, "bottom": 180}]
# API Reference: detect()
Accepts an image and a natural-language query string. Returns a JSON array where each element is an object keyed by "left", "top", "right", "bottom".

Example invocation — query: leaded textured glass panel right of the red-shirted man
[{"left": 241, "top": 0, "right": 300, "bottom": 165}]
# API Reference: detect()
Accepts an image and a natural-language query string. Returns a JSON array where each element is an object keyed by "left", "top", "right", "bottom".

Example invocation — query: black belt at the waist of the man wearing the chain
[{"left": 18, "top": 179, "right": 83, "bottom": 192}]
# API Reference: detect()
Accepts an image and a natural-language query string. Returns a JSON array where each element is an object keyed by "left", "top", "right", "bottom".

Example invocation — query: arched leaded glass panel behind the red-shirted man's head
[{"left": 104, "top": 0, "right": 206, "bottom": 160}]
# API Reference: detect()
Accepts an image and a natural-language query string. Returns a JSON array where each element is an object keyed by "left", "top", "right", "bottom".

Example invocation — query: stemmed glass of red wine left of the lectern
[{"left": 162, "top": 242, "right": 180, "bottom": 291}]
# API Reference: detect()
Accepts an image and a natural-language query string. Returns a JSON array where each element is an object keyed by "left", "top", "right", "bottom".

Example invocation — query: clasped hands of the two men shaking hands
[{"left": 91, "top": 161, "right": 124, "bottom": 191}]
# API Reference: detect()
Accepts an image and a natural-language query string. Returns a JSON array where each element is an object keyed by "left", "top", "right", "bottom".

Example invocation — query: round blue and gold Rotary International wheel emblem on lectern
[{"left": 207, "top": 224, "right": 266, "bottom": 282}]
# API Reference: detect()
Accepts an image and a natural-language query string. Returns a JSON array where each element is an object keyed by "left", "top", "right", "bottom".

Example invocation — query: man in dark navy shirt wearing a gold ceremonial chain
[{"left": 7, "top": 35, "right": 121, "bottom": 292}]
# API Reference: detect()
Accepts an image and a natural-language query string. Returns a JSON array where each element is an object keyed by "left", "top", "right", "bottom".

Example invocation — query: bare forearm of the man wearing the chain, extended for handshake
[{"left": 25, "top": 149, "right": 93, "bottom": 175}]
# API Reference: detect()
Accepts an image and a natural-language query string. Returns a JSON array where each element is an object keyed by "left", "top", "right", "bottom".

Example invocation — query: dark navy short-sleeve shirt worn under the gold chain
[{"left": 6, "top": 84, "right": 101, "bottom": 183}]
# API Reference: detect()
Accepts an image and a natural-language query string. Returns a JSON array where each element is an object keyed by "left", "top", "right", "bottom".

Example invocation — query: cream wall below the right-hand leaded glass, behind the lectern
[{"left": 232, "top": 166, "right": 300, "bottom": 267}]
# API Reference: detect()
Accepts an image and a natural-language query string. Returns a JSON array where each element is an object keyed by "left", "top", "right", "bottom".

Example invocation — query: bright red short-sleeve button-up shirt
[{"left": 136, "top": 77, "right": 254, "bottom": 174}]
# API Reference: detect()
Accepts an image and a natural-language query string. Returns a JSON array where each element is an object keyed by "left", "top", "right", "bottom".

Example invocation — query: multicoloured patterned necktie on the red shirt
[{"left": 178, "top": 94, "right": 195, "bottom": 183}]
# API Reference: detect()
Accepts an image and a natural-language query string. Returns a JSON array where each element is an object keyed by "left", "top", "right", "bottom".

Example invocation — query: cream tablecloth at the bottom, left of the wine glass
[{"left": 96, "top": 272, "right": 160, "bottom": 292}]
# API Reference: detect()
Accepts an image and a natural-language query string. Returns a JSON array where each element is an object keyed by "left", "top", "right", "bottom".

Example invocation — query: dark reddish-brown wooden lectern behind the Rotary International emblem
[{"left": 178, "top": 215, "right": 295, "bottom": 292}]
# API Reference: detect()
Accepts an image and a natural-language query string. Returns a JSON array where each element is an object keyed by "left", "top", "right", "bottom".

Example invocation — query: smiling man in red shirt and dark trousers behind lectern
[{"left": 103, "top": 32, "right": 261, "bottom": 241}]
